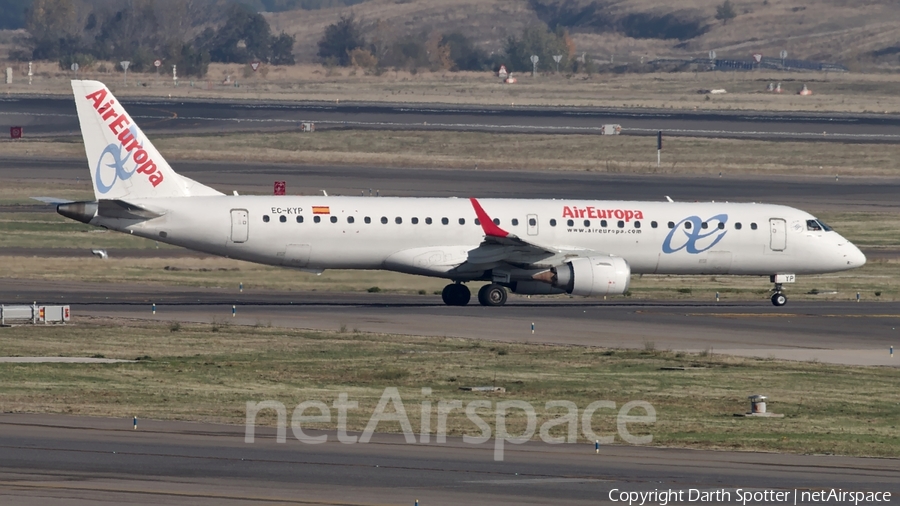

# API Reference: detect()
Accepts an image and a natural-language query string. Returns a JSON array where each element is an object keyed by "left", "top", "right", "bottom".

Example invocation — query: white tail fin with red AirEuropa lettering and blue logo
[{"left": 72, "top": 81, "right": 222, "bottom": 200}]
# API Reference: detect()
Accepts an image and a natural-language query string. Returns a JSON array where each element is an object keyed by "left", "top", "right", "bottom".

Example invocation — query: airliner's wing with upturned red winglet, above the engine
[{"left": 461, "top": 198, "right": 603, "bottom": 267}]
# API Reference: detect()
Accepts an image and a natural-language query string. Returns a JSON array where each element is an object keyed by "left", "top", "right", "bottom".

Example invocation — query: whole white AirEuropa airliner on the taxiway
[{"left": 58, "top": 81, "right": 866, "bottom": 306}]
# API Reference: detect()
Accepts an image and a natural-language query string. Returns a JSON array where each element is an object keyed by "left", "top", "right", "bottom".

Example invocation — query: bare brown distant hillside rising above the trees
[{"left": 265, "top": 0, "right": 900, "bottom": 70}]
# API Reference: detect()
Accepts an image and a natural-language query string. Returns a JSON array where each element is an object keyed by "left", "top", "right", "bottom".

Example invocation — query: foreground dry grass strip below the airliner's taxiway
[{"left": 0, "top": 317, "right": 900, "bottom": 457}]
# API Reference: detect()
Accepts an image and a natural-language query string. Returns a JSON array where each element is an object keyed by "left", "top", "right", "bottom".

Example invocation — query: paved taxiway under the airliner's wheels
[{"left": 0, "top": 279, "right": 900, "bottom": 367}]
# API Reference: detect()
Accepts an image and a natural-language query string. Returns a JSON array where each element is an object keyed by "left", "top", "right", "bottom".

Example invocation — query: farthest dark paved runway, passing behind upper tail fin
[{"left": 0, "top": 97, "right": 900, "bottom": 142}]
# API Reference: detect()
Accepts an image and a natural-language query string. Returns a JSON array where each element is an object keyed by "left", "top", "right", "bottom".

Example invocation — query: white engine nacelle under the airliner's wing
[{"left": 552, "top": 256, "right": 631, "bottom": 297}]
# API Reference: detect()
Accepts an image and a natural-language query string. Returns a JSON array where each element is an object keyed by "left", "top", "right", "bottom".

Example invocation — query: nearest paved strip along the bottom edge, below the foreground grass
[{"left": 0, "top": 414, "right": 900, "bottom": 506}]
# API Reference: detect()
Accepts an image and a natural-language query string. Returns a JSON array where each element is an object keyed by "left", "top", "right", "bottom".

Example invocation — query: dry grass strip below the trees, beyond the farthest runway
[{"left": 8, "top": 58, "right": 900, "bottom": 114}]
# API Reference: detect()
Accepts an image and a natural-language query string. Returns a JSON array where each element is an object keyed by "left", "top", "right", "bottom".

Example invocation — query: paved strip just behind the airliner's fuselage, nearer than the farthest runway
[{"left": 7, "top": 157, "right": 900, "bottom": 211}]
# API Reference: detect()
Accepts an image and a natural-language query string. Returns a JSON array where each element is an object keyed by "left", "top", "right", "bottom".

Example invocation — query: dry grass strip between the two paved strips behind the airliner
[{"left": 0, "top": 130, "right": 900, "bottom": 178}]
